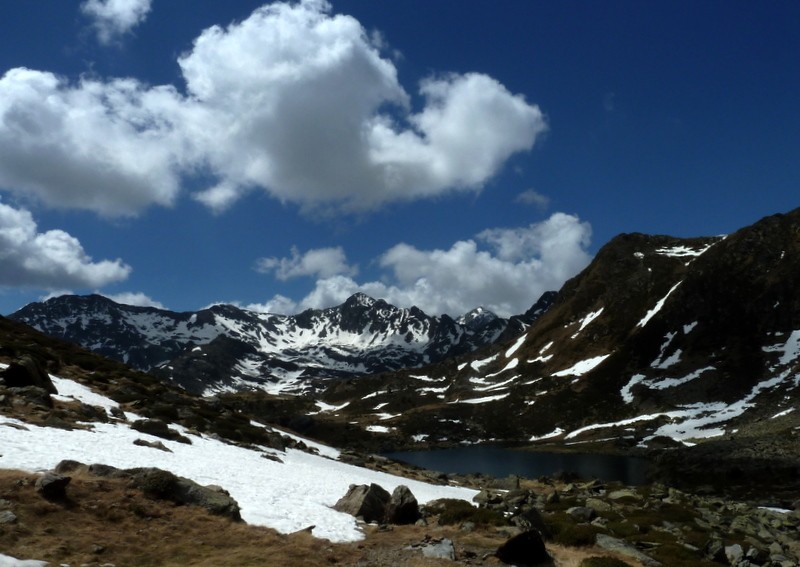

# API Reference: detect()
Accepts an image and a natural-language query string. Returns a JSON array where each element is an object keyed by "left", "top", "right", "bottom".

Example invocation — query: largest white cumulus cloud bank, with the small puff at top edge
[{"left": 0, "top": 0, "right": 547, "bottom": 215}]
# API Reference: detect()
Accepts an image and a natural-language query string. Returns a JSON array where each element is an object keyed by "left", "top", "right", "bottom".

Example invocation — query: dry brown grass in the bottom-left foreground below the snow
[{"left": 0, "top": 470, "right": 648, "bottom": 567}]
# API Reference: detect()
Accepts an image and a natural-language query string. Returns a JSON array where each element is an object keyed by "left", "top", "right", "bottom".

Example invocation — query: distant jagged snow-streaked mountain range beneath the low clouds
[{"left": 10, "top": 293, "right": 554, "bottom": 394}]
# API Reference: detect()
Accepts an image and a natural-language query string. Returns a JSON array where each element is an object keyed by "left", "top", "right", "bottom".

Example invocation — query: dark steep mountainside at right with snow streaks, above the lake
[{"left": 318, "top": 209, "right": 800, "bottom": 460}]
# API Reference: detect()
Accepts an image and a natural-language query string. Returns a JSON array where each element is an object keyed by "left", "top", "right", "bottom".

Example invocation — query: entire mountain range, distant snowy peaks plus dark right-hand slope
[{"left": 11, "top": 209, "right": 800, "bottom": 466}]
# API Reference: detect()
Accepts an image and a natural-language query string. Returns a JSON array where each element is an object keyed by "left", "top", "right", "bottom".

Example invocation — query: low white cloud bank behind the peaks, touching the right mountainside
[{"left": 251, "top": 213, "right": 591, "bottom": 317}]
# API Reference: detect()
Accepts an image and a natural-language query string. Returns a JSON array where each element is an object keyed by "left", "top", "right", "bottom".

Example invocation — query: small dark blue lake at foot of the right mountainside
[{"left": 384, "top": 445, "right": 648, "bottom": 485}]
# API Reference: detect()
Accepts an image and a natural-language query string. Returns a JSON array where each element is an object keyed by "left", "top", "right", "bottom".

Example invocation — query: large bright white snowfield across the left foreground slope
[{"left": 0, "top": 377, "right": 476, "bottom": 542}]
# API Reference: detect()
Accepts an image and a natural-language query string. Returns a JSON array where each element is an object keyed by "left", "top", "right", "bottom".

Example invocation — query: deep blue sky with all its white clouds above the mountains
[{"left": 0, "top": 0, "right": 800, "bottom": 315}]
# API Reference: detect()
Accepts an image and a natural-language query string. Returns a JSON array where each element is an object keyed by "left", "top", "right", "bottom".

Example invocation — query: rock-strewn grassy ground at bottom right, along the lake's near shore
[{"left": 342, "top": 452, "right": 800, "bottom": 567}]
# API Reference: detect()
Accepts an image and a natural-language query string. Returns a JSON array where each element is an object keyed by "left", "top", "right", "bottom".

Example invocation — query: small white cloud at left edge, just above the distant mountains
[{"left": 0, "top": 203, "right": 131, "bottom": 290}]
